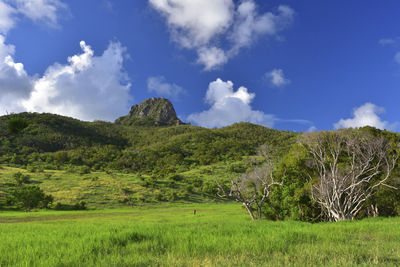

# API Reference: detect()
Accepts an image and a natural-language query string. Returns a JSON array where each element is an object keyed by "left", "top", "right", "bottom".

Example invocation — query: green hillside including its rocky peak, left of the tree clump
[{"left": 0, "top": 99, "right": 298, "bottom": 208}]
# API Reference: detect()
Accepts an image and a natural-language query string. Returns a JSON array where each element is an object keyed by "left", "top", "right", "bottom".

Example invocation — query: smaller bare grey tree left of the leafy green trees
[{"left": 216, "top": 148, "right": 282, "bottom": 220}]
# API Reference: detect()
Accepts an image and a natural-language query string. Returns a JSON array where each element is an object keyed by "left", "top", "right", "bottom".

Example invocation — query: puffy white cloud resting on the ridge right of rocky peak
[{"left": 188, "top": 79, "right": 275, "bottom": 128}]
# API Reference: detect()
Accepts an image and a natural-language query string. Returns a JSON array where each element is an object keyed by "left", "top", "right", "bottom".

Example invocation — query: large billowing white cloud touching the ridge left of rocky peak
[{"left": 21, "top": 41, "right": 130, "bottom": 120}]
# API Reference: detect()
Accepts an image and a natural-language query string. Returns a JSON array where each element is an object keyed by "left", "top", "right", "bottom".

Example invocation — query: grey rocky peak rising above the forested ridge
[{"left": 115, "top": 97, "right": 184, "bottom": 126}]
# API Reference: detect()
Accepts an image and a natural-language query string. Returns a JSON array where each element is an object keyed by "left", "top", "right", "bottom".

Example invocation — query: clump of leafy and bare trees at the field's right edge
[{"left": 218, "top": 127, "right": 400, "bottom": 222}]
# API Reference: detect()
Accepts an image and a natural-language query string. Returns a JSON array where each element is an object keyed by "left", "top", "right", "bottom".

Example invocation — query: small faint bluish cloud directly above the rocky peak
[{"left": 147, "top": 76, "right": 184, "bottom": 99}]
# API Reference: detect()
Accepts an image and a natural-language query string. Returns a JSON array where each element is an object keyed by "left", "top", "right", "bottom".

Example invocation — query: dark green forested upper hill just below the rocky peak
[{"left": 0, "top": 110, "right": 298, "bottom": 175}]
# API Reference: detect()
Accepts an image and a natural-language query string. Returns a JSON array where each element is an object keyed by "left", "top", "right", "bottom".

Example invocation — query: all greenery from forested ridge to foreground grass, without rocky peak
[{"left": 0, "top": 110, "right": 400, "bottom": 266}]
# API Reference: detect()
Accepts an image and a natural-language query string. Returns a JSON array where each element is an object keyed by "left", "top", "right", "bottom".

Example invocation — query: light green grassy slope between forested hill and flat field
[{"left": 0, "top": 164, "right": 235, "bottom": 208}]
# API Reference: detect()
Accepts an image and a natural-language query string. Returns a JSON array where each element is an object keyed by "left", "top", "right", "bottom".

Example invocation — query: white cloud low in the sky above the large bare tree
[{"left": 334, "top": 103, "right": 389, "bottom": 129}]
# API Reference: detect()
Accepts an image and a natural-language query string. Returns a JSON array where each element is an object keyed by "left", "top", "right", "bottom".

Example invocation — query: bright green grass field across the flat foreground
[{"left": 0, "top": 204, "right": 400, "bottom": 266}]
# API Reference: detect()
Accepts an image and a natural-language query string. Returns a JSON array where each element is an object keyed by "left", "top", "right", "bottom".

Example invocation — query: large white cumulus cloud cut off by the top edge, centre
[{"left": 149, "top": 0, "right": 294, "bottom": 70}]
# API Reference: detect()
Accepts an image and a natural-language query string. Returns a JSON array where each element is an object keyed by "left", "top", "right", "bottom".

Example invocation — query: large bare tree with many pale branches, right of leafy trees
[{"left": 302, "top": 130, "right": 399, "bottom": 221}]
